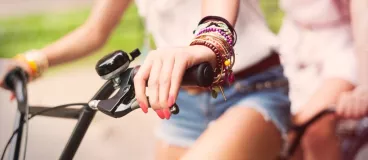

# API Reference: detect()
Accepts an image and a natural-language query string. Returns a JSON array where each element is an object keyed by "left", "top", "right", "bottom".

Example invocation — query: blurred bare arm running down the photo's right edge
[{"left": 350, "top": 0, "right": 368, "bottom": 86}]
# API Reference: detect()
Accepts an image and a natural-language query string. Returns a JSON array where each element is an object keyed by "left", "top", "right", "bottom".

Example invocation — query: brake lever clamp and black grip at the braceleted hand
[{"left": 89, "top": 63, "right": 213, "bottom": 118}]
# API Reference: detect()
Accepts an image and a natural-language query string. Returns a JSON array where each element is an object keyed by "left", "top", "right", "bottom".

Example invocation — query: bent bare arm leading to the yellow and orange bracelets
[{"left": 40, "top": 0, "right": 130, "bottom": 66}]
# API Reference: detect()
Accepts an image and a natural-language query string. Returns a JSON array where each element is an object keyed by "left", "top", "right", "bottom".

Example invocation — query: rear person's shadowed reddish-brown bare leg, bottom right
[{"left": 302, "top": 115, "right": 341, "bottom": 160}]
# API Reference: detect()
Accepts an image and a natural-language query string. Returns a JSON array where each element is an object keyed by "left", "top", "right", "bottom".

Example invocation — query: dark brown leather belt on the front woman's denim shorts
[{"left": 184, "top": 51, "right": 281, "bottom": 94}]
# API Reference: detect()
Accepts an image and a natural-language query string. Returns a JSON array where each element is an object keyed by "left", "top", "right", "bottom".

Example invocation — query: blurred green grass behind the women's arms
[{"left": 0, "top": 0, "right": 283, "bottom": 72}]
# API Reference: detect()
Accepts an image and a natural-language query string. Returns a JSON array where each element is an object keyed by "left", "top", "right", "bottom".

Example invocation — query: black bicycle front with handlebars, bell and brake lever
[{"left": 1, "top": 49, "right": 213, "bottom": 160}]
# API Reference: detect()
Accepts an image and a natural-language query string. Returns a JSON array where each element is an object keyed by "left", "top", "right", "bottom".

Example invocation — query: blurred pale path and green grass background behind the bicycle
[{"left": 0, "top": 0, "right": 283, "bottom": 160}]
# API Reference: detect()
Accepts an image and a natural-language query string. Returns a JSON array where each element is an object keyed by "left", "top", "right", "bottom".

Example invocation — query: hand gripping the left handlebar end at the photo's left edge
[{"left": 0, "top": 59, "right": 31, "bottom": 89}]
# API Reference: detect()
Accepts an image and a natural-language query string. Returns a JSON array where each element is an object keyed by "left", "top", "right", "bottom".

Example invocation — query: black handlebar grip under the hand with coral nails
[{"left": 132, "top": 62, "right": 214, "bottom": 87}]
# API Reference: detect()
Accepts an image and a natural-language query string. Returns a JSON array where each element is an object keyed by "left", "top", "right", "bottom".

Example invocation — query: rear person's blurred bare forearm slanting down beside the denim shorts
[{"left": 294, "top": 78, "right": 354, "bottom": 124}]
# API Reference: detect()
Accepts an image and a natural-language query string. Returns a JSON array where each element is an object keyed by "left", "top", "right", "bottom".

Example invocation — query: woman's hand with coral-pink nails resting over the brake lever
[{"left": 134, "top": 46, "right": 216, "bottom": 119}]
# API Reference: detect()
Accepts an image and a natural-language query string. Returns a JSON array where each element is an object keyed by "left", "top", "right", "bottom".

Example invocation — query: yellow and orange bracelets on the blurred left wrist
[{"left": 15, "top": 50, "right": 48, "bottom": 80}]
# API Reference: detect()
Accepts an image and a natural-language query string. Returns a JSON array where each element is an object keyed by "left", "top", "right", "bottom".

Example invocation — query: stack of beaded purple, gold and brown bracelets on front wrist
[{"left": 190, "top": 16, "right": 236, "bottom": 100}]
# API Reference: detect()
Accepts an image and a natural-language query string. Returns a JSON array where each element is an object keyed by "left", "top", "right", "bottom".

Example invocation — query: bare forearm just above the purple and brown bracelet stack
[{"left": 202, "top": 0, "right": 240, "bottom": 26}]
